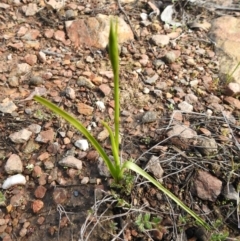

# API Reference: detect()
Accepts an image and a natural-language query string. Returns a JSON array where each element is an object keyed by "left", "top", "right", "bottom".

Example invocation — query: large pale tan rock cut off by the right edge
[{"left": 209, "top": 16, "right": 240, "bottom": 83}]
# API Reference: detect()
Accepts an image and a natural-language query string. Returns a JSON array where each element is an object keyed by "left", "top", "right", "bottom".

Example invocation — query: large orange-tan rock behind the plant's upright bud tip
[{"left": 65, "top": 14, "right": 134, "bottom": 48}]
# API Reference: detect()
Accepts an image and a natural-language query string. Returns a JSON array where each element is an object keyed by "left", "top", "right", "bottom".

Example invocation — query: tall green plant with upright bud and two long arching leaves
[{"left": 34, "top": 18, "right": 210, "bottom": 229}]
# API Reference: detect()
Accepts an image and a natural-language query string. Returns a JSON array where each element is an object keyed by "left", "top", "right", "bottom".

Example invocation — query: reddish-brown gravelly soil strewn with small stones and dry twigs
[{"left": 0, "top": 0, "right": 240, "bottom": 241}]
